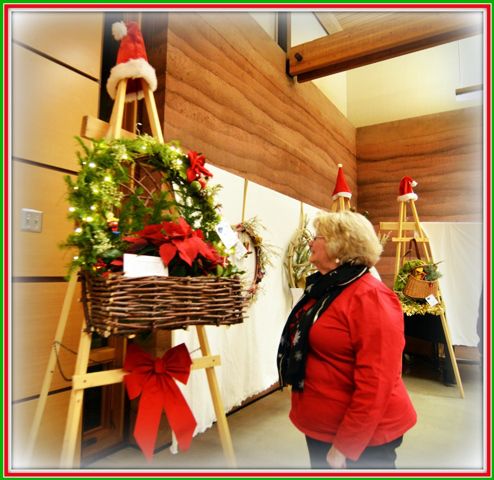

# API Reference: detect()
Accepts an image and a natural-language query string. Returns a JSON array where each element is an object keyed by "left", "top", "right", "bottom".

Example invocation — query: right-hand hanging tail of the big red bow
[{"left": 163, "top": 378, "right": 197, "bottom": 451}]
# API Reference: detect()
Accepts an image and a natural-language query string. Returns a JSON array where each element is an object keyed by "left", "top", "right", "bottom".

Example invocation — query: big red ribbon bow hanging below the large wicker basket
[{"left": 124, "top": 343, "right": 197, "bottom": 461}]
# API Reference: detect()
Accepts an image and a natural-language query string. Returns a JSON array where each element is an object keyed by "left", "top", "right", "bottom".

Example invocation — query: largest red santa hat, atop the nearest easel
[{"left": 106, "top": 22, "right": 158, "bottom": 102}]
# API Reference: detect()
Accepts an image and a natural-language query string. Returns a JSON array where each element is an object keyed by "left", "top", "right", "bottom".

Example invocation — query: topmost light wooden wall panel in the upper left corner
[{"left": 12, "top": 12, "right": 103, "bottom": 79}]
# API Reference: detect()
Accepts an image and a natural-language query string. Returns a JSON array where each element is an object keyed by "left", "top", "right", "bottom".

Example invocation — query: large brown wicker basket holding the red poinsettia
[{"left": 82, "top": 273, "right": 246, "bottom": 336}]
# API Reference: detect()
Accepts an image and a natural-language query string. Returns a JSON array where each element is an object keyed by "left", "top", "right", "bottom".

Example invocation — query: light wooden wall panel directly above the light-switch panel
[{"left": 12, "top": 45, "right": 99, "bottom": 170}]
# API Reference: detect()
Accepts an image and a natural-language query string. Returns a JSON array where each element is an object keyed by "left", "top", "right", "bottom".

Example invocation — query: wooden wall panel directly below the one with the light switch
[{"left": 12, "top": 282, "right": 83, "bottom": 400}]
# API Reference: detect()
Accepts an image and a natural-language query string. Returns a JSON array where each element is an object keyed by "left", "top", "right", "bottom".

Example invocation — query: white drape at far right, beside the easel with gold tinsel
[{"left": 421, "top": 222, "right": 483, "bottom": 347}]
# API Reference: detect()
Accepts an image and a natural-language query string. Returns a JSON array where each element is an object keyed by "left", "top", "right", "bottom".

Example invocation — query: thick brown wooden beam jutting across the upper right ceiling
[{"left": 287, "top": 12, "right": 482, "bottom": 82}]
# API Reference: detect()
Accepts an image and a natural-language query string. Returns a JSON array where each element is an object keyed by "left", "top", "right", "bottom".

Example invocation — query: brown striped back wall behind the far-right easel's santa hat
[{"left": 357, "top": 107, "right": 483, "bottom": 286}]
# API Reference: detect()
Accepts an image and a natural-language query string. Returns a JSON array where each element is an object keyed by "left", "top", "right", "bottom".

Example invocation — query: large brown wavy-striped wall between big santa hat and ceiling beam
[{"left": 162, "top": 13, "right": 357, "bottom": 207}]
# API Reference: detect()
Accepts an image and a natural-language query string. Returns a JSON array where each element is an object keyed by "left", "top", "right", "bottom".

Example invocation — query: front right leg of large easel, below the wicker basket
[{"left": 197, "top": 325, "right": 237, "bottom": 467}]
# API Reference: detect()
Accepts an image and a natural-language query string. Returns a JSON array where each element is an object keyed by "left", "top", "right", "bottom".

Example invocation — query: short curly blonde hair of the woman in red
[{"left": 314, "top": 211, "right": 383, "bottom": 267}]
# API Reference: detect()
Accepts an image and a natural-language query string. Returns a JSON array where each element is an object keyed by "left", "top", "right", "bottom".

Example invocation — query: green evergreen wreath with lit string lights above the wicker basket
[{"left": 63, "top": 135, "right": 223, "bottom": 272}]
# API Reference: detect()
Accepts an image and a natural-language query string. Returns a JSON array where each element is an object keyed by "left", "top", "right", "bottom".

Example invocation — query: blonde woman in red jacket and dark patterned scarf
[{"left": 278, "top": 211, "right": 417, "bottom": 468}]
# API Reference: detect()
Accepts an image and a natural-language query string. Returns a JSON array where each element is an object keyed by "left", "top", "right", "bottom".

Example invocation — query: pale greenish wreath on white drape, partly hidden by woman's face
[{"left": 285, "top": 215, "right": 315, "bottom": 288}]
